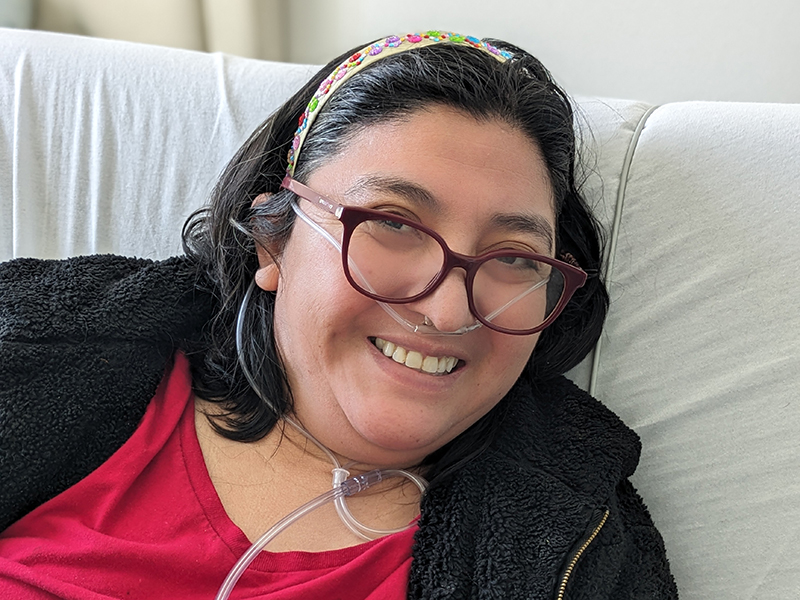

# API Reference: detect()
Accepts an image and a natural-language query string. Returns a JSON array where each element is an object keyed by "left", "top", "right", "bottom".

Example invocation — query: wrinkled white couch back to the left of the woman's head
[{"left": 0, "top": 30, "right": 316, "bottom": 260}]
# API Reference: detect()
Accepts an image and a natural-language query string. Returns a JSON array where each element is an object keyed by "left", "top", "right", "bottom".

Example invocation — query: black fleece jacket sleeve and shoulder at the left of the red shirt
[{"left": 0, "top": 256, "right": 212, "bottom": 530}]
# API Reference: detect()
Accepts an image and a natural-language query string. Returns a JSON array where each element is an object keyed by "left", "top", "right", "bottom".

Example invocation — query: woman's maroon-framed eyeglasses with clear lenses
[{"left": 281, "top": 175, "right": 586, "bottom": 335}]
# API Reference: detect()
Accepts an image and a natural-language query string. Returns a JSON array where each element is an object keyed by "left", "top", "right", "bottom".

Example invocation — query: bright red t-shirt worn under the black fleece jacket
[{"left": 0, "top": 354, "right": 415, "bottom": 600}]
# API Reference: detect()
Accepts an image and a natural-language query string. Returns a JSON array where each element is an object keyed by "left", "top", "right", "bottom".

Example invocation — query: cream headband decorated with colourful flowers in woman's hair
[{"left": 286, "top": 31, "right": 512, "bottom": 176}]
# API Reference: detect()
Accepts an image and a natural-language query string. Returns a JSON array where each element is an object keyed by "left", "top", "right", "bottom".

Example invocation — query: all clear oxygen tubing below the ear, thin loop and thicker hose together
[{"left": 215, "top": 282, "right": 428, "bottom": 600}]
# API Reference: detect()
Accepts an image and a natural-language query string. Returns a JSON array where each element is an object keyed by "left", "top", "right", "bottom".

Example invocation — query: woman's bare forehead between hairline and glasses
[{"left": 308, "top": 106, "right": 554, "bottom": 223}]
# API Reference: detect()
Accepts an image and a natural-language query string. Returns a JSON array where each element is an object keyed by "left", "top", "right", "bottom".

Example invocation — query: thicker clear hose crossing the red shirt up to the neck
[{"left": 214, "top": 469, "right": 416, "bottom": 600}]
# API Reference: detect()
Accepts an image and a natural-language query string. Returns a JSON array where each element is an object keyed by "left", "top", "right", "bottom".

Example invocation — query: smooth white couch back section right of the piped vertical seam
[{"left": 596, "top": 103, "right": 800, "bottom": 600}]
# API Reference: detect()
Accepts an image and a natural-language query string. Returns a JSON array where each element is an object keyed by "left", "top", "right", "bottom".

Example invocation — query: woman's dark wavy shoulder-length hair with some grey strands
[{"left": 183, "top": 40, "right": 608, "bottom": 486}]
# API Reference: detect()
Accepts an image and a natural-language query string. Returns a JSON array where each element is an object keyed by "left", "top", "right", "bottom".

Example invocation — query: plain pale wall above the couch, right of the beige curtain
[{"left": 289, "top": 0, "right": 800, "bottom": 103}]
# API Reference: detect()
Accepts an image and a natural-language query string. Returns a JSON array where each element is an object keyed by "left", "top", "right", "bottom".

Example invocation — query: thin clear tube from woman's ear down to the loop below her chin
[{"left": 236, "top": 280, "right": 428, "bottom": 540}]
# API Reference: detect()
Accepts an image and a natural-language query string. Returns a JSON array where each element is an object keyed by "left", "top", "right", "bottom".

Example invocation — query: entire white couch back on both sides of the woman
[{"left": 0, "top": 30, "right": 800, "bottom": 600}]
